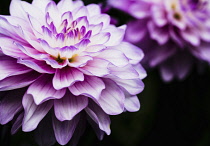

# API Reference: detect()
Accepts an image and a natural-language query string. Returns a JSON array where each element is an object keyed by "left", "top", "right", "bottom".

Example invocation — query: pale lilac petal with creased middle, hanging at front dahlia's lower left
[{"left": 22, "top": 91, "right": 53, "bottom": 132}]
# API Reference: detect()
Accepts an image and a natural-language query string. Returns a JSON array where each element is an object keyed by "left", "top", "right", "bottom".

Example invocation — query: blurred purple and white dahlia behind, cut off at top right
[{"left": 109, "top": 0, "right": 210, "bottom": 81}]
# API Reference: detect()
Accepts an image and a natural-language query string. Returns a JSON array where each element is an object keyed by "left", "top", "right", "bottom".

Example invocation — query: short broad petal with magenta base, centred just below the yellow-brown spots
[{"left": 53, "top": 67, "right": 84, "bottom": 90}]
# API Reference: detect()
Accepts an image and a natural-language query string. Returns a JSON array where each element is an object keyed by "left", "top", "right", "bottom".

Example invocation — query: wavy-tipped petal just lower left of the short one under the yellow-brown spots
[{"left": 27, "top": 75, "right": 66, "bottom": 105}]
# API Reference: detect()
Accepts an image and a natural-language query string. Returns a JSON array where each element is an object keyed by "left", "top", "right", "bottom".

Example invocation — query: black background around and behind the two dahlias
[{"left": 0, "top": 0, "right": 210, "bottom": 146}]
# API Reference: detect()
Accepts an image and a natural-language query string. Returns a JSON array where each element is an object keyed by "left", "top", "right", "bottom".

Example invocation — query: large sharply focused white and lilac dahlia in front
[{"left": 0, "top": 0, "right": 146, "bottom": 145}]
